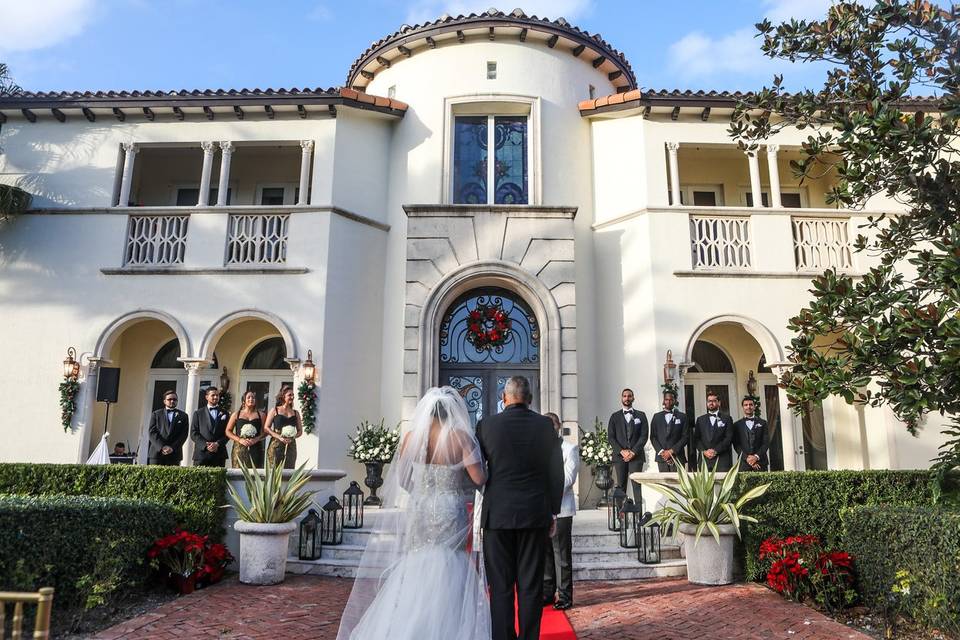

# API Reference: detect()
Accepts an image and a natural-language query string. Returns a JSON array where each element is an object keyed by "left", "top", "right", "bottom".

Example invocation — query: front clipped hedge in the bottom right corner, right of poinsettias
[{"left": 842, "top": 506, "right": 960, "bottom": 635}]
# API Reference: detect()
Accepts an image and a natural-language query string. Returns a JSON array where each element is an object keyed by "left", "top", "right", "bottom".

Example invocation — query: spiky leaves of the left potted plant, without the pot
[{"left": 227, "top": 459, "right": 316, "bottom": 524}]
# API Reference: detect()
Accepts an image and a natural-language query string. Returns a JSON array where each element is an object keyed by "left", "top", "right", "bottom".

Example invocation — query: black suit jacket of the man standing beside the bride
[{"left": 477, "top": 404, "right": 563, "bottom": 529}]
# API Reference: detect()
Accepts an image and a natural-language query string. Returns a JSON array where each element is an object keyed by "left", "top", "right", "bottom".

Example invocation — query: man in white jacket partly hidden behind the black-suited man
[{"left": 543, "top": 413, "right": 580, "bottom": 611}]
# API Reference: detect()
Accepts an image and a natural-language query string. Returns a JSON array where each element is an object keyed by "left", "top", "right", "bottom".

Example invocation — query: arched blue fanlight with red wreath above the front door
[{"left": 440, "top": 289, "right": 540, "bottom": 366}]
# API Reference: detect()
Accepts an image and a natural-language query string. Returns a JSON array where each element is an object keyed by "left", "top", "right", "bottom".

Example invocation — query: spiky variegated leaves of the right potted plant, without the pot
[{"left": 642, "top": 455, "right": 770, "bottom": 544}]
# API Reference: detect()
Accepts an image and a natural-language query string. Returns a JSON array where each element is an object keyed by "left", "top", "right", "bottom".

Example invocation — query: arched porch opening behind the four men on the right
[{"left": 683, "top": 321, "right": 793, "bottom": 471}]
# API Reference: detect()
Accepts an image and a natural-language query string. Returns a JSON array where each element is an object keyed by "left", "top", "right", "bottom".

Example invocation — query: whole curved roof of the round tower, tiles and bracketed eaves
[{"left": 346, "top": 9, "right": 637, "bottom": 91}]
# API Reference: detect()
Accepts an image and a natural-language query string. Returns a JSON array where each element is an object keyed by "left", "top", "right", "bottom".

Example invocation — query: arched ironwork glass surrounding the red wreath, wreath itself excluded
[{"left": 440, "top": 289, "right": 540, "bottom": 365}]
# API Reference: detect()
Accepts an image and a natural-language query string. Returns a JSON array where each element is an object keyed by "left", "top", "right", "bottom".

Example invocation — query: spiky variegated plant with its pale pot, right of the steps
[{"left": 642, "top": 456, "right": 770, "bottom": 585}]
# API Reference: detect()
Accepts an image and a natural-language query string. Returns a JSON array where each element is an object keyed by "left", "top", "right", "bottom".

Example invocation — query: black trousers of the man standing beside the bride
[{"left": 488, "top": 527, "right": 550, "bottom": 640}]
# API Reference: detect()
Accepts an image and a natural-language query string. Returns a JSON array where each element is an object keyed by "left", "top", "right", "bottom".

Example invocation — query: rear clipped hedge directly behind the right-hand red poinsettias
[{"left": 738, "top": 471, "right": 933, "bottom": 579}]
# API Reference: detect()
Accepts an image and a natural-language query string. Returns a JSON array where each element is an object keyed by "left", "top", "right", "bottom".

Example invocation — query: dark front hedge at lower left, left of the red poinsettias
[{"left": 0, "top": 495, "right": 176, "bottom": 607}]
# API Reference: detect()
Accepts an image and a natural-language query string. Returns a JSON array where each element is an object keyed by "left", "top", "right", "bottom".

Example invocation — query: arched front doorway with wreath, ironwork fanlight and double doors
[{"left": 437, "top": 287, "right": 541, "bottom": 425}]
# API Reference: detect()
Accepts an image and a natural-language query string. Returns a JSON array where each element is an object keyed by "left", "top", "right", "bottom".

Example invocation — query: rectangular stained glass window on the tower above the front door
[{"left": 453, "top": 116, "right": 529, "bottom": 204}]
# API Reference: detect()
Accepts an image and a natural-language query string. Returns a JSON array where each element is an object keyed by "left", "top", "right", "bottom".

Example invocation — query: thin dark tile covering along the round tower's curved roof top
[{"left": 346, "top": 9, "right": 637, "bottom": 89}]
